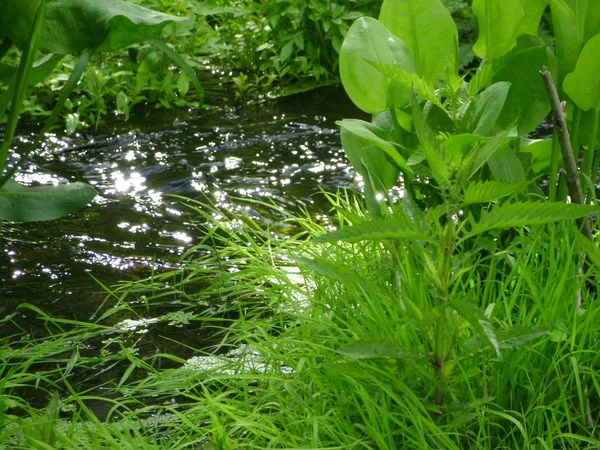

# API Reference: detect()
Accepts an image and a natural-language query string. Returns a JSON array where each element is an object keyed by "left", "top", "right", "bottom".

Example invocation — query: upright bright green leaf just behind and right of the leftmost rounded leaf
[{"left": 379, "top": 0, "right": 458, "bottom": 83}]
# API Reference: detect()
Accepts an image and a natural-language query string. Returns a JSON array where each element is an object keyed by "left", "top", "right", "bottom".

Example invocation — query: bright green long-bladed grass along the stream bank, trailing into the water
[{"left": 0, "top": 192, "right": 600, "bottom": 449}]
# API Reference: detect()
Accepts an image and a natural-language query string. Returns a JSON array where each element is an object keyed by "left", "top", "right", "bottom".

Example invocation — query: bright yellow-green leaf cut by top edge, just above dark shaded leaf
[{"left": 473, "top": 0, "right": 525, "bottom": 60}]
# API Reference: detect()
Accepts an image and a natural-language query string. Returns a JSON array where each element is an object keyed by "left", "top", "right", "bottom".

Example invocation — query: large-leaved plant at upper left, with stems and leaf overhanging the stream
[{"left": 0, "top": 0, "right": 203, "bottom": 222}]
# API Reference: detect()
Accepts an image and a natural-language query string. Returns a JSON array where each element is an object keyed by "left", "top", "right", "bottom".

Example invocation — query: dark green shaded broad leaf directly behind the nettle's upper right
[{"left": 493, "top": 37, "right": 551, "bottom": 136}]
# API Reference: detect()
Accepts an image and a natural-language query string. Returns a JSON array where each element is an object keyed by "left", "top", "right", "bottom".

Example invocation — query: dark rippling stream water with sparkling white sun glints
[{"left": 0, "top": 89, "right": 359, "bottom": 326}]
